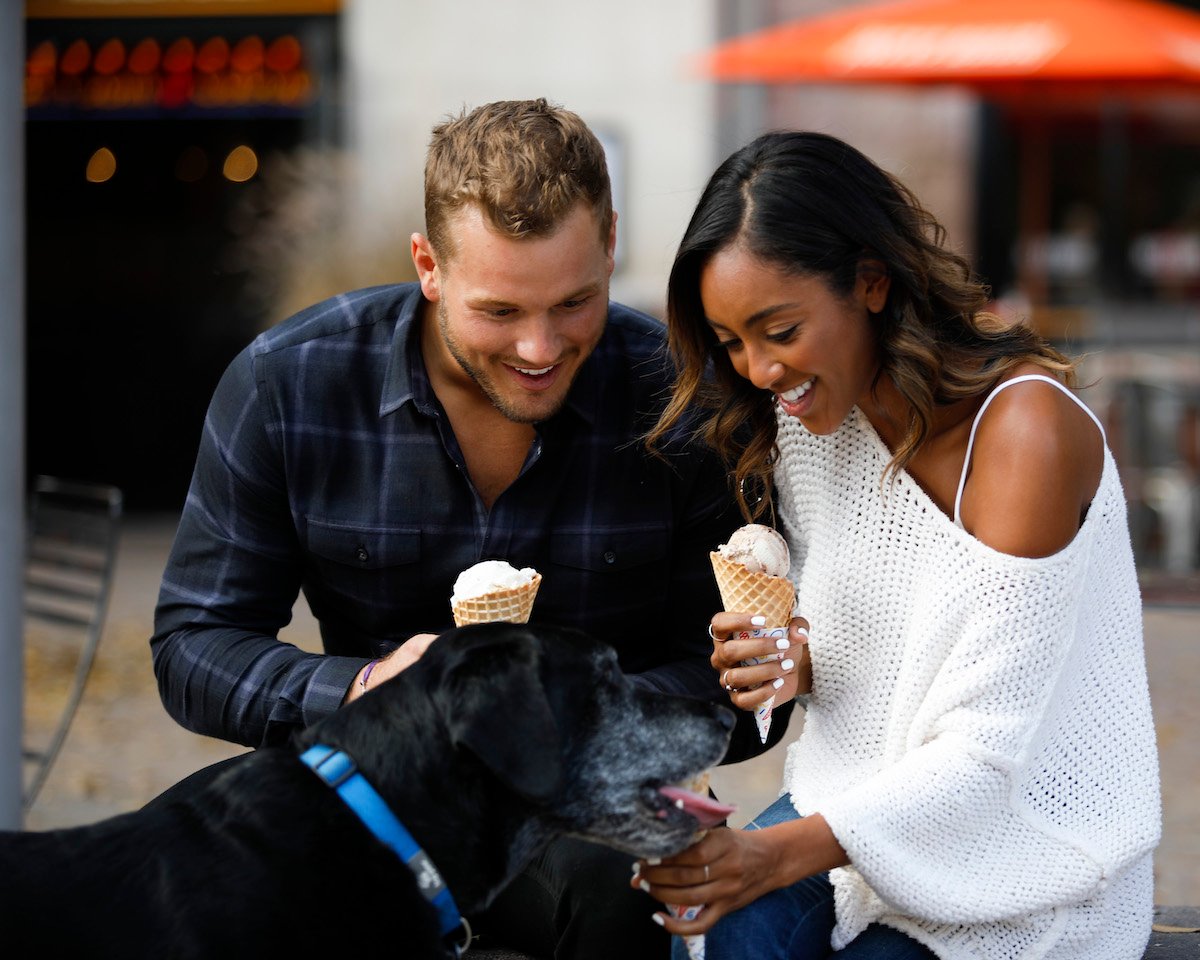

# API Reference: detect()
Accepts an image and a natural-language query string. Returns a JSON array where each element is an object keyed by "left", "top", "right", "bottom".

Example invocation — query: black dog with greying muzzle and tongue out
[{"left": 0, "top": 624, "right": 732, "bottom": 960}]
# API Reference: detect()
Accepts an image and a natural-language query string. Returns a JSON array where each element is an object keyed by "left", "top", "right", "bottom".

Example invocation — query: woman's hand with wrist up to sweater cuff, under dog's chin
[{"left": 630, "top": 814, "right": 848, "bottom": 936}]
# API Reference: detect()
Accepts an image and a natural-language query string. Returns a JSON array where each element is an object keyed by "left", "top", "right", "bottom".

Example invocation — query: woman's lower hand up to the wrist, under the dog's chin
[{"left": 631, "top": 827, "right": 784, "bottom": 936}]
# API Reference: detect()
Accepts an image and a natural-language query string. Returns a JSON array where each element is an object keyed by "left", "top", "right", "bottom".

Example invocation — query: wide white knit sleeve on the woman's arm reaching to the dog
[{"left": 814, "top": 542, "right": 1123, "bottom": 924}]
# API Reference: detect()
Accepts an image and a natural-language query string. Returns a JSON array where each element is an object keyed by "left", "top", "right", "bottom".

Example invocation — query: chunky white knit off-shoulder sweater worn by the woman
[{"left": 776, "top": 398, "right": 1160, "bottom": 960}]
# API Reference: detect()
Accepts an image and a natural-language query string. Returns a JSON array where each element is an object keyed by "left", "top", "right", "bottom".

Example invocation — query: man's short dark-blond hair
[{"left": 425, "top": 100, "right": 612, "bottom": 259}]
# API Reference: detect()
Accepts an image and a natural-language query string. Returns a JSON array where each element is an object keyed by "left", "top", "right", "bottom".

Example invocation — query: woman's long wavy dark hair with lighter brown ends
[{"left": 647, "top": 132, "right": 1074, "bottom": 520}]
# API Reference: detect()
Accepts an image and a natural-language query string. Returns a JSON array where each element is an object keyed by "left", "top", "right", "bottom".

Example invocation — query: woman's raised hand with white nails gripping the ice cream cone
[{"left": 709, "top": 613, "right": 812, "bottom": 710}]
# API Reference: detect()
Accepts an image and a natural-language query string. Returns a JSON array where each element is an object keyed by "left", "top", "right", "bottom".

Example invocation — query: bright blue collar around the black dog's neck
[{"left": 300, "top": 744, "right": 470, "bottom": 955}]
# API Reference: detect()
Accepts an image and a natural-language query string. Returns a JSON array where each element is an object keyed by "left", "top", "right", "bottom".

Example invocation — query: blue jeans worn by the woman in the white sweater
[{"left": 671, "top": 794, "right": 936, "bottom": 960}]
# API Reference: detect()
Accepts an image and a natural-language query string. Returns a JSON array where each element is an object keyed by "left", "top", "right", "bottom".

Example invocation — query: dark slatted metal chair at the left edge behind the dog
[{"left": 24, "top": 476, "right": 122, "bottom": 810}]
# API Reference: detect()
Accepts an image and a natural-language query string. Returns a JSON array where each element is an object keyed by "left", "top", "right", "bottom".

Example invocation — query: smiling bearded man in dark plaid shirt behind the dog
[{"left": 151, "top": 100, "right": 784, "bottom": 958}]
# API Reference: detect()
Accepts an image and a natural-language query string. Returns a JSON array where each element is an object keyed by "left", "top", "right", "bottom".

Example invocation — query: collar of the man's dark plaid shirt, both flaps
[{"left": 379, "top": 283, "right": 610, "bottom": 425}]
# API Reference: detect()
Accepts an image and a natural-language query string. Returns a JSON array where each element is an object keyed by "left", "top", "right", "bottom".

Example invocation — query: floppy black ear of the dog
[{"left": 445, "top": 642, "right": 564, "bottom": 803}]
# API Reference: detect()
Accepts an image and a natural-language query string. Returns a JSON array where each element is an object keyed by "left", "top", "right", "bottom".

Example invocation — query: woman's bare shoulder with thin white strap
[{"left": 960, "top": 364, "right": 1104, "bottom": 557}]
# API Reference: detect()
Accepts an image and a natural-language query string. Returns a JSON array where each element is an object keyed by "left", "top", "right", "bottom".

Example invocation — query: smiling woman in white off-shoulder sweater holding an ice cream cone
[{"left": 634, "top": 133, "right": 1159, "bottom": 960}]
